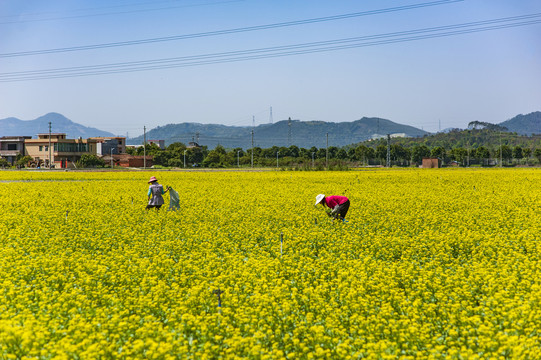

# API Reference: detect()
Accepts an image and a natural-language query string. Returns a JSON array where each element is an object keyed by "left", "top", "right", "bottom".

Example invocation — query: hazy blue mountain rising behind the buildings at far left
[{"left": 0, "top": 113, "right": 114, "bottom": 139}]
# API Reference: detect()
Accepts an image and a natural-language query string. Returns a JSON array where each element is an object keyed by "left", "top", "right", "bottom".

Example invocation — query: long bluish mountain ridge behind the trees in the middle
[{"left": 128, "top": 117, "right": 428, "bottom": 149}]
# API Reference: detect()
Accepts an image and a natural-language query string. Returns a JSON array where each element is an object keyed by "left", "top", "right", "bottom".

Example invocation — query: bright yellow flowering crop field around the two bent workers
[{"left": 0, "top": 169, "right": 541, "bottom": 359}]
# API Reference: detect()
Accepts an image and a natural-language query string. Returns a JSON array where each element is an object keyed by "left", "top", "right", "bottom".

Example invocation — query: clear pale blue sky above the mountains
[{"left": 0, "top": 0, "right": 541, "bottom": 136}]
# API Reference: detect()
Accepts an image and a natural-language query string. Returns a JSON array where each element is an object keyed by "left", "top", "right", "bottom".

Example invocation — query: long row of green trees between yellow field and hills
[{"left": 124, "top": 140, "right": 541, "bottom": 169}]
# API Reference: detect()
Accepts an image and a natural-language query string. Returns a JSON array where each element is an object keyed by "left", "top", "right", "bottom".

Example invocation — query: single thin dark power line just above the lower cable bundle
[{"left": 0, "top": 0, "right": 464, "bottom": 58}]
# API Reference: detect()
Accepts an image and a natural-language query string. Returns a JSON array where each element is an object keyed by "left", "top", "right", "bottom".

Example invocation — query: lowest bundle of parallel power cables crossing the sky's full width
[{"left": 0, "top": 13, "right": 541, "bottom": 82}]
